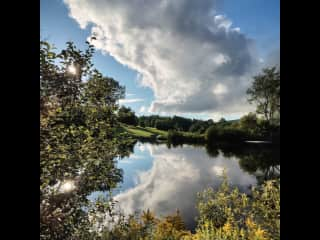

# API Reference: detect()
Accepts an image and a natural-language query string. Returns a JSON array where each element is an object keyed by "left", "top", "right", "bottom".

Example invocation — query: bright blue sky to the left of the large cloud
[{"left": 40, "top": 0, "right": 153, "bottom": 110}]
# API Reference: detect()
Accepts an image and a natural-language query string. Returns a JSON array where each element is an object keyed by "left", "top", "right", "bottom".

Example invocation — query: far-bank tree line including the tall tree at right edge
[{"left": 118, "top": 67, "right": 280, "bottom": 143}]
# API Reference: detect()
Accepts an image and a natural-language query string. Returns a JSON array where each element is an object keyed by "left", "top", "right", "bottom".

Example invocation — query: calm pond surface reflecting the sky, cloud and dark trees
[{"left": 91, "top": 142, "right": 280, "bottom": 230}]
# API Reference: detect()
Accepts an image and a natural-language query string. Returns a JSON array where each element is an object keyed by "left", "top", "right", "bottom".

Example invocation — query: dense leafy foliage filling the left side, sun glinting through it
[{"left": 40, "top": 41, "right": 130, "bottom": 239}]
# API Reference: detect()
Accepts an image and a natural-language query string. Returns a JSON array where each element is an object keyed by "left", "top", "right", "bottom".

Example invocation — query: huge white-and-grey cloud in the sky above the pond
[{"left": 65, "top": 0, "right": 276, "bottom": 116}]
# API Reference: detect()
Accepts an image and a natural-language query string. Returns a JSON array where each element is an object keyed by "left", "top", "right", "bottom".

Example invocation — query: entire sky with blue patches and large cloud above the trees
[{"left": 40, "top": 0, "right": 280, "bottom": 120}]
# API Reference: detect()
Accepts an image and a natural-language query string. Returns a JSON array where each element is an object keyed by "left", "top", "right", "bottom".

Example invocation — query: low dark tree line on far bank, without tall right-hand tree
[{"left": 118, "top": 110, "right": 280, "bottom": 143}]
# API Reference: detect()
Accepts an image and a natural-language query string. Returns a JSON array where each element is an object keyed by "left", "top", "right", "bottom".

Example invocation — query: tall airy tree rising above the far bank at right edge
[{"left": 247, "top": 67, "right": 280, "bottom": 123}]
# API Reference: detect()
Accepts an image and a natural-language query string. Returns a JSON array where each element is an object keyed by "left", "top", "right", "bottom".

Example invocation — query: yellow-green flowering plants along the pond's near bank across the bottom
[{"left": 92, "top": 177, "right": 280, "bottom": 240}]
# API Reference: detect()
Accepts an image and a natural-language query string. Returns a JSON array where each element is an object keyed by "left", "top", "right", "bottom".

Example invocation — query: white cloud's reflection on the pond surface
[{"left": 115, "top": 144, "right": 256, "bottom": 228}]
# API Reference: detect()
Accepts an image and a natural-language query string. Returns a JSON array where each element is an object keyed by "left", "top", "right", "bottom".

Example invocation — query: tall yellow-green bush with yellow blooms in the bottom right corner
[{"left": 189, "top": 179, "right": 280, "bottom": 240}]
